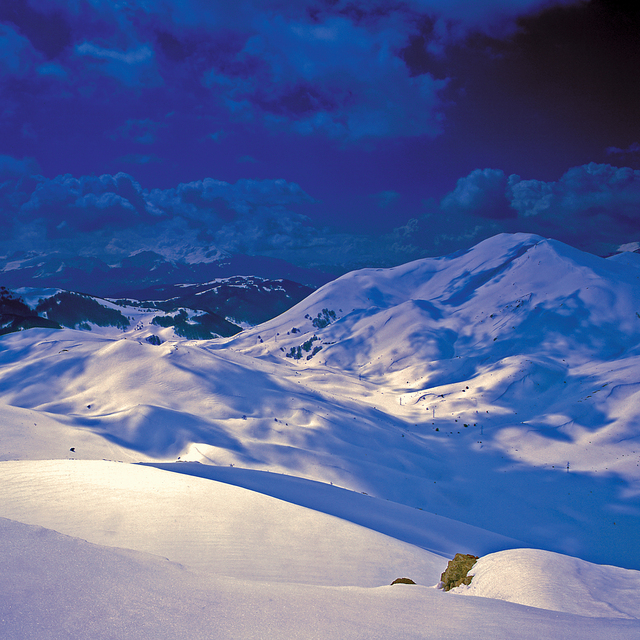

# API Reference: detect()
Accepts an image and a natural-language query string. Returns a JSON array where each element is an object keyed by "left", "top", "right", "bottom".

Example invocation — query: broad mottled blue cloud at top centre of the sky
[{"left": 195, "top": 10, "right": 446, "bottom": 140}]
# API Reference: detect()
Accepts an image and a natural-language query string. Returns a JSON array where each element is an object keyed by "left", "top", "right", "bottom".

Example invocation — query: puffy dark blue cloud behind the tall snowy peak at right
[{"left": 430, "top": 163, "right": 640, "bottom": 255}]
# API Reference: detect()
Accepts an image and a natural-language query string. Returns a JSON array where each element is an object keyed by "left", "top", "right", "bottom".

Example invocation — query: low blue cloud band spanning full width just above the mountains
[{"left": 0, "top": 158, "right": 640, "bottom": 271}]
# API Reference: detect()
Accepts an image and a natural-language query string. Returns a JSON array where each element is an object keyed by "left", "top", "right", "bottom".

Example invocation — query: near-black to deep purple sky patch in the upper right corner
[{"left": 430, "top": 0, "right": 640, "bottom": 176}]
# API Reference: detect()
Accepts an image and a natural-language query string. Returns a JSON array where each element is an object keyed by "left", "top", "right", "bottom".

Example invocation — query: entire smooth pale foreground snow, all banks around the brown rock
[{"left": 0, "top": 460, "right": 640, "bottom": 640}]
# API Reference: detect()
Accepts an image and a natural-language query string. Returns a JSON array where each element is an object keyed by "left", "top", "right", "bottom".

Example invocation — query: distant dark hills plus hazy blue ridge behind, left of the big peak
[{"left": 0, "top": 251, "right": 322, "bottom": 340}]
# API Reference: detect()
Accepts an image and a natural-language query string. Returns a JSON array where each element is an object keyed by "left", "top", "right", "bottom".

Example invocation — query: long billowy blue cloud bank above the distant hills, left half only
[{"left": 0, "top": 168, "right": 318, "bottom": 262}]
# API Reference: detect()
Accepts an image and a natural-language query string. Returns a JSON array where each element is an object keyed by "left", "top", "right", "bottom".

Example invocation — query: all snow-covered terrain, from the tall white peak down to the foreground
[{"left": 0, "top": 234, "right": 640, "bottom": 639}]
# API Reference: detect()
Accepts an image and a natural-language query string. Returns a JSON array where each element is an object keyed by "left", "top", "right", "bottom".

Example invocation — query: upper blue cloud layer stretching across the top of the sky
[{"left": 0, "top": 0, "right": 640, "bottom": 154}]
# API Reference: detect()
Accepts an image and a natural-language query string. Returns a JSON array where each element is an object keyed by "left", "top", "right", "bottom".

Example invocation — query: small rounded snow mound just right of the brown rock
[{"left": 451, "top": 549, "right": 640, "bottom": 616}]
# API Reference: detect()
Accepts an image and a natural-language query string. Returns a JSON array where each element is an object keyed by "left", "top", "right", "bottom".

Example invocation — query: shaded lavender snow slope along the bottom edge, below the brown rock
[{"left": 0, "top": 518, "right": 640, "bottom": 640}]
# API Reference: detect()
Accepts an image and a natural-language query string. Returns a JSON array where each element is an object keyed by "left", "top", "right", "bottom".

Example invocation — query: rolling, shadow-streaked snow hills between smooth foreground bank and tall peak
[{"left": 0, "top": 318, "right": 640, "bottom": 568}]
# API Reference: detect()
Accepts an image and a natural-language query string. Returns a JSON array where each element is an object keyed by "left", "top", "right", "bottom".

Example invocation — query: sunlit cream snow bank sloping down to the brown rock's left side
[{"left": 0, "top": 460, "right": 446, "bottom": 587}]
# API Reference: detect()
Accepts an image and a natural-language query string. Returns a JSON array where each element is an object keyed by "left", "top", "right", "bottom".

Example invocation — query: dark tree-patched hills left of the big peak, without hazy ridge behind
[{"left": 0, "top": 276, "right": 313, "bottom": 344}]
